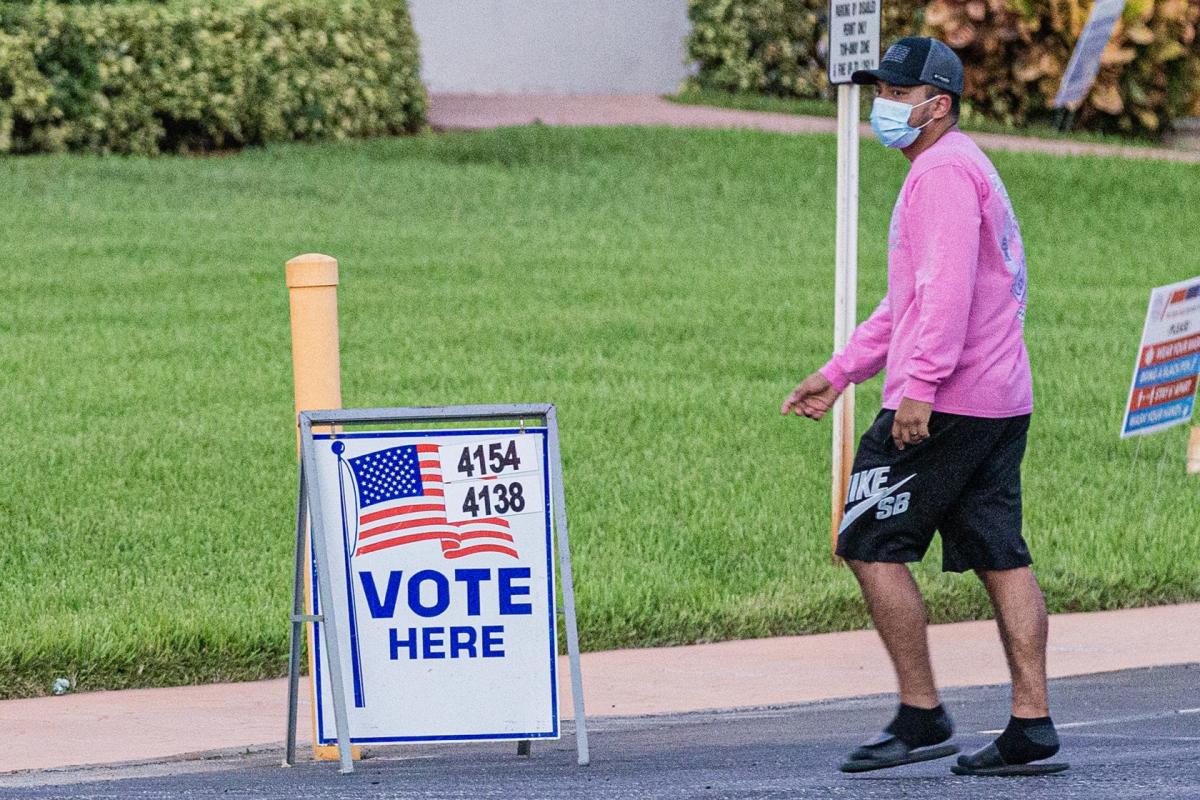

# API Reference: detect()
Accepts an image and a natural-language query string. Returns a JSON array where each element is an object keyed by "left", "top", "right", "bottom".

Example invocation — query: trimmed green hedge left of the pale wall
[{"left": 0, "top": 0, "right": 426, "bottom": 155}]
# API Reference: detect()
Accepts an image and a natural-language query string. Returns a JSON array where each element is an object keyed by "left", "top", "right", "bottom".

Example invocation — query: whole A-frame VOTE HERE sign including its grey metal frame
[{"left": 286, "top": 404, "right": 589, "bottom": 772}]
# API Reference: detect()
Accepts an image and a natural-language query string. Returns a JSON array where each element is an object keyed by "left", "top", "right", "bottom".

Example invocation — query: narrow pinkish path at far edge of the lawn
[{"left": 428, "top": 95, "right": 1200, "bottom": 163}]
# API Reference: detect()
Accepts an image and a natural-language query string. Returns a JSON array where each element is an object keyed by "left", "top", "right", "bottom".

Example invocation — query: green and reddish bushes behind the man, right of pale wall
[{"left": 688, "top": 0, "right": 1200, "bottom": 134}]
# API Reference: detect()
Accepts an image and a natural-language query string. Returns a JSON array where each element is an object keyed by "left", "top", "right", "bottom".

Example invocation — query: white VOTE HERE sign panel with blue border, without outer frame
[{"left": 304, "top": 428, "right": 559, "bottom": 744}]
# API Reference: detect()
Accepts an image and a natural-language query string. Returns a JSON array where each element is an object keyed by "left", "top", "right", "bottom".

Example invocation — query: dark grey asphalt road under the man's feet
[{"left": 7, "top": 664, "right": 1200, "bottom": 800}]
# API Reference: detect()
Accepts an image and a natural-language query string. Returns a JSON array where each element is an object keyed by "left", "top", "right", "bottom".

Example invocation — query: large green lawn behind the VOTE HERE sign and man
[{"left": 0, "top": 126, "right": 1200, "bottom": 696}]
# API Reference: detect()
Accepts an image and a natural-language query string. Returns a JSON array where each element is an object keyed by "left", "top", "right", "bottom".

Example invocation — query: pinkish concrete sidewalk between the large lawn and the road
[{"left": 7, "top": 603, "right": 1200, "bottom": 772}]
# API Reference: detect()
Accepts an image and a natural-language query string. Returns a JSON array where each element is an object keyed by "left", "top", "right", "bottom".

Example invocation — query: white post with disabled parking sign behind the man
[{"left": 828, "top": 0, "right": 880, "bottom": 563}]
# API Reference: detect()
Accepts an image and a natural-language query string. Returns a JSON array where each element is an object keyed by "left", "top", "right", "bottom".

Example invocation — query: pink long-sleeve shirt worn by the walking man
[{"left": 821, "top": 131, "right": 1033, "bottom": 417}]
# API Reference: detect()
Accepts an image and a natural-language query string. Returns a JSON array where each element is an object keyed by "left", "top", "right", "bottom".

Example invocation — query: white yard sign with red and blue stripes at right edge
[{"left": 1121, "top": 276, "right": 1200, "bottom": 439}]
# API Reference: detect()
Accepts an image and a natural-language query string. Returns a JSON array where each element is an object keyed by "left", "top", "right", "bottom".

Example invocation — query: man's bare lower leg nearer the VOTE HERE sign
[{"left": 847, "top": 560, "right": 940, "bottom": 709}]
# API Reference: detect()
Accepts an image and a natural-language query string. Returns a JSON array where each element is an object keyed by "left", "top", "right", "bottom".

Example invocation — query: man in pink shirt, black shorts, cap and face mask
[{"left": 782, "top": 37, "right": 1067, "bottom": 775}]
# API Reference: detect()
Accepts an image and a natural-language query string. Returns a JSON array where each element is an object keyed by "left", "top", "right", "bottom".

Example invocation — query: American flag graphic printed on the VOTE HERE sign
[{"left": 347, "top": 445, "right": 517, "bottom": 559}]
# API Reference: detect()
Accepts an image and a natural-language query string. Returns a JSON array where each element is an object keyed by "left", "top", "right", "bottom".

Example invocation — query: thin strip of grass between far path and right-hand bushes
[{"left": 667, "top": 86, "right": 1163, "bottom": 148}]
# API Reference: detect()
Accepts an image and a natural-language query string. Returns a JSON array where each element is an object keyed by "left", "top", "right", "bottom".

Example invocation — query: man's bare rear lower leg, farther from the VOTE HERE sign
[{"left": 977, "top": 566, "right": 1050, "bottom": 718}]
